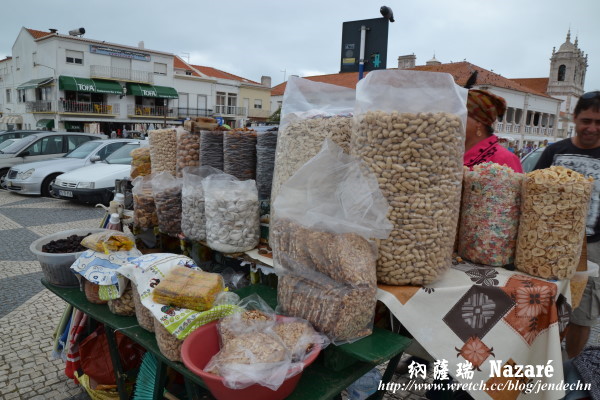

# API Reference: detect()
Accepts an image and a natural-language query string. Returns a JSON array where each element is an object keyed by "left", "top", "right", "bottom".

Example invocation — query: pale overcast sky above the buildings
[{"left": 0, "top": 0, "right": 600, "bottom": 91}]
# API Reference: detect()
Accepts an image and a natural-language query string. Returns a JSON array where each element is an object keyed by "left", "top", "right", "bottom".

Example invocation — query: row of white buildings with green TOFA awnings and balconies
[{"left": 0, "top": 28, "right": 270, "bottom": 134}]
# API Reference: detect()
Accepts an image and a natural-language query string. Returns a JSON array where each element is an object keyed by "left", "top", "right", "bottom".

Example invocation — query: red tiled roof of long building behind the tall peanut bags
[{"left": 271, "top": 61, "right": 550, "bottom": 97}]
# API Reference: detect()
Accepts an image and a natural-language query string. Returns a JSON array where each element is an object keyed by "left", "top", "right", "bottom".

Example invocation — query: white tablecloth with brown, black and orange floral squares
[{"left": 377, "top": 264, "right": 571, "bottom": 400}]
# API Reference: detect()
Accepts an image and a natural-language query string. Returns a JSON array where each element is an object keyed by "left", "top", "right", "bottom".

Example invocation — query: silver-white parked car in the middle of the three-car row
[{"left": 5, "top": 139, "right": 135, "bottom": 197}]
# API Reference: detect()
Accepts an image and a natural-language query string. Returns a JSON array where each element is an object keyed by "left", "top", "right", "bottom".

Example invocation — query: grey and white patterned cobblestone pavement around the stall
[{"left": 0, "top": 190, "right": 600, "bottom": 400}]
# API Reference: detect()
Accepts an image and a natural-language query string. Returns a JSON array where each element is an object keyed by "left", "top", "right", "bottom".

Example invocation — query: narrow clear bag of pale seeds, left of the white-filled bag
[{"left": 181, "top": 165, "right": 222, "bottom": 241}]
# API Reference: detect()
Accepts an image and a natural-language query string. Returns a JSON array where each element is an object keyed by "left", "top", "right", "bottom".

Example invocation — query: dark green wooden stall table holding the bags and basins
[{"left": 42, "top": 279, "right": 411, "bottom": 400}]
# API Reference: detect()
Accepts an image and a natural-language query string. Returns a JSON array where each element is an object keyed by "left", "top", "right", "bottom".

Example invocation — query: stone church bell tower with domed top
[{"left": 546, "top": 29, "right": 588, "bottom": 137}]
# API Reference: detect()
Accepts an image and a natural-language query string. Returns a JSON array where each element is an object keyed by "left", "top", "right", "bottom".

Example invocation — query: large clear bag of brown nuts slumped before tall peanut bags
[{"left": 271, "top": 139, "right": 392, "bottom": 344}]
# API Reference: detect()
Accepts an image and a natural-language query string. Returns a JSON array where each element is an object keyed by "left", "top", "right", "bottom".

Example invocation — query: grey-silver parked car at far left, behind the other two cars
[{"left": 0, "top": 131, "right": 106, "bottom": 189}]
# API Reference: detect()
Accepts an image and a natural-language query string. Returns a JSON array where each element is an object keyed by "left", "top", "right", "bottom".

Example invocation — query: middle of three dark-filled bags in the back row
[{"left": 223, "top": 128, "right": 256, "bottom": 181}]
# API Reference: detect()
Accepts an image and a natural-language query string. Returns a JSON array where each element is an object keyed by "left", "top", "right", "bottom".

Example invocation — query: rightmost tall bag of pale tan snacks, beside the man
[{"left": 515, "top": 166, "right": 593, "bottom": 279}]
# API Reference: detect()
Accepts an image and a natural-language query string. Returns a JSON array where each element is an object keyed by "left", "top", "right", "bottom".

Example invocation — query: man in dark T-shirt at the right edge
[{"left": 535, "top": 91, "right": 600, "bottom": 358}]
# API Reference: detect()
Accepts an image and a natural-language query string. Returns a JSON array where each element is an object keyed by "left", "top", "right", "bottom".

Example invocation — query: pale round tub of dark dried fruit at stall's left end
[{"left": 29, "top": 228, "right": 105, "bottom": 287}]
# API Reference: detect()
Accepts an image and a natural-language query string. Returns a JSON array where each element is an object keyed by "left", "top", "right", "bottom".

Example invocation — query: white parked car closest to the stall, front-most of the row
[{"left": 52, "top": 140, "right": 148, "bottom": 204}]
